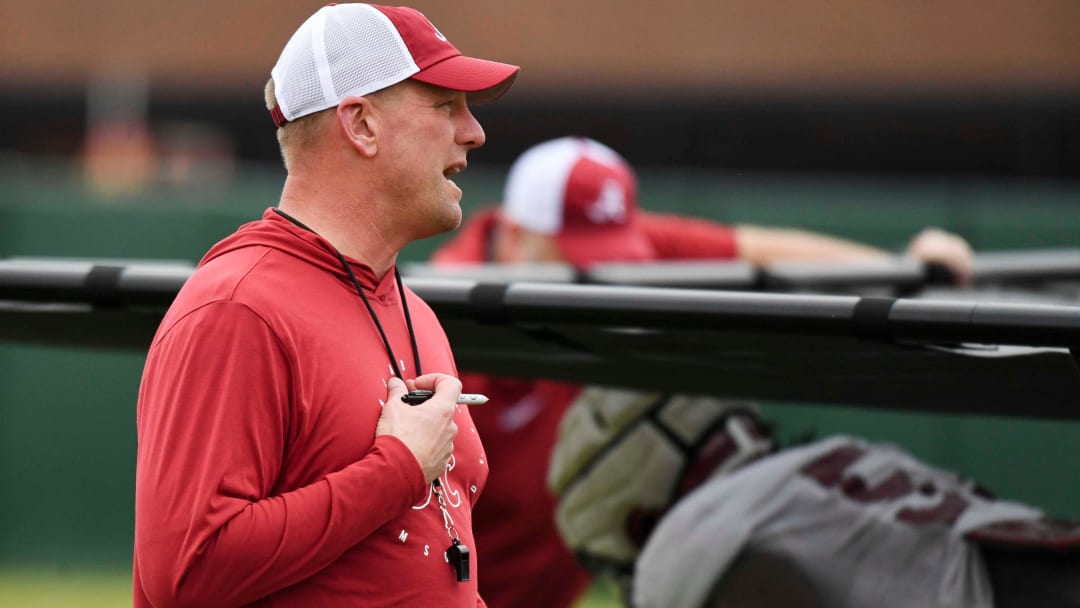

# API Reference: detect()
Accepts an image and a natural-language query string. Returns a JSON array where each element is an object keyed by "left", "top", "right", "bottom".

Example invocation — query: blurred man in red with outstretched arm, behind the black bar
[{"left": 432, "top": 137, "right": 972, "bottom": 608}]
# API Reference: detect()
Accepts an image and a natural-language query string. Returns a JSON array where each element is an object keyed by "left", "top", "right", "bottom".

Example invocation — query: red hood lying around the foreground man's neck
[{"left": 199, "top": 207, "right": 395, "bottom": 297}]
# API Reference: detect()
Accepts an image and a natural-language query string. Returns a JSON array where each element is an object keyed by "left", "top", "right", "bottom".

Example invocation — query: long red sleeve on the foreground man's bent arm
[{"left": 135, "top": 301, "right": 426, "bottom": 607}]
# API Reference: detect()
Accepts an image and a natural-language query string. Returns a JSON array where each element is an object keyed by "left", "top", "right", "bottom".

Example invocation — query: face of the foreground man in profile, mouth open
[{"left": 378, "top": 80, "right": 484, "bottom": 239}]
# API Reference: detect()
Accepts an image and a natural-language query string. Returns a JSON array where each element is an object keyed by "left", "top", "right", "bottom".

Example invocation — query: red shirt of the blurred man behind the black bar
[{"left": 432, "top": 210, "right": 737, "bottom": 608}]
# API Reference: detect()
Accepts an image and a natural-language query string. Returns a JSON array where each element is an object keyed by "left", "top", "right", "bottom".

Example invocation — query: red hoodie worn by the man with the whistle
[{"left": 134, "top": 210, "right": 488, "bottom": 608}]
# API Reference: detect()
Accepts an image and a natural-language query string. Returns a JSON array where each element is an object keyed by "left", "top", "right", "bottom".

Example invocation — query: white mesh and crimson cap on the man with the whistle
[{"left": 270, "top": 3, "right": 519, "bottom": 126}]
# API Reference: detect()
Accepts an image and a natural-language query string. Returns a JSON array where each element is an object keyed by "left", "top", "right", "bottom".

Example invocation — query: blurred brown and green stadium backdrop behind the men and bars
[{"left": 0, "top": 0, "right": 1080, "bottom": 606}]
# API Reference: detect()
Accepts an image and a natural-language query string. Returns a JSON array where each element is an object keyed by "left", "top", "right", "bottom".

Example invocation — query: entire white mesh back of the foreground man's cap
[{"left": 270, "top": 4, "right": 419, "bottom": 120}]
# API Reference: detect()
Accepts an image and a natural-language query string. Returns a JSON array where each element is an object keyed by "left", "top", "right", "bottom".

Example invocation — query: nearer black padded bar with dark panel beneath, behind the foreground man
[{"left": 0, "top": 262, "right": 1080, "bottom": 419}]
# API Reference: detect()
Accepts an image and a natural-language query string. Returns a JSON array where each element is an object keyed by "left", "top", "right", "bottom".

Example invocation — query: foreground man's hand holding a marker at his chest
[{"left": 375, "top": 374, "right": 461, "bottom": 483}]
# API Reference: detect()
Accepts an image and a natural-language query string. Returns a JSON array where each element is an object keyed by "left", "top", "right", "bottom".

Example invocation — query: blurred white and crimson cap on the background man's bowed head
[{"left": 502, "top": 137, "right": 657, "bottom": 268}]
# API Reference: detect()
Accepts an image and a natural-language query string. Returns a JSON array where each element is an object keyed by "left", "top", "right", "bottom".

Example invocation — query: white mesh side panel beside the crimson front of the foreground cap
[{"left": 326, "top": 6, "right": 419, "bottom": 99}]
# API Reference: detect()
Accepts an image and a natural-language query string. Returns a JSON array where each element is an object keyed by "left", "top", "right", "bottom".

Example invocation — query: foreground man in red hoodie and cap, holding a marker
[{"left": 134, "top": 4, "right": 518, "bottom": 608}]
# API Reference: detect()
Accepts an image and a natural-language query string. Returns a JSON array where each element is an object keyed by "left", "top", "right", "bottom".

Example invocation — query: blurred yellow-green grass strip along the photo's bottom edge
[{"left": 0, "top": 567, "right": 620, "bottom": 608}]
